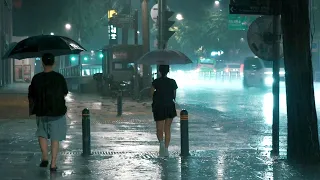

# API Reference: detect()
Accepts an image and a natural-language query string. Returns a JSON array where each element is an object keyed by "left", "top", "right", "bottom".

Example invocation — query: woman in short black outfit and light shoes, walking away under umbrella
[{"left": 151, "top": 65, "right": 178, "bottom": 156}]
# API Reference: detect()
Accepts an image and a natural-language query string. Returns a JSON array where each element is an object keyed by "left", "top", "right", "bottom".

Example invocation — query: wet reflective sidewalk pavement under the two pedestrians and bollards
[{"left": 0, "top": 90, "right": 320, "bottom": 180}]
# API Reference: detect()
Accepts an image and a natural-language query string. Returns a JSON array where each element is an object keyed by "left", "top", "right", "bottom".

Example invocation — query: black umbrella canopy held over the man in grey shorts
[{"left": 3, "top": 35, "right": 86, "bottom": 59}]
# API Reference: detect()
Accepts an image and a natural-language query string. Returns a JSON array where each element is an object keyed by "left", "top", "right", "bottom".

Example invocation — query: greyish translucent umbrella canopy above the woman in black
[{"left": 138, "top": 50, "right": 192, "bottom": 65}]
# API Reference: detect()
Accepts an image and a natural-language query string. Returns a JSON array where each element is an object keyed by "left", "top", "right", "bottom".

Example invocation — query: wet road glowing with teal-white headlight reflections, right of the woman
[{"left": 177, "top": 79, "right": 320, "bottom": 155}]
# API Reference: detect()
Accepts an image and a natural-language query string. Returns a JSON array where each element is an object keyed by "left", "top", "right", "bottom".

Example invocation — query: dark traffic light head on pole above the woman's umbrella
[{"left": 162, "top": 10, "right": 175, "bottom": 44}]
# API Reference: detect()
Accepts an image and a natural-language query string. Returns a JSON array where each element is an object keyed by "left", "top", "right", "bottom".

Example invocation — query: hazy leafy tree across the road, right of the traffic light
[{"left": 169, "top": 8, "right": 228, "bottom": 55}]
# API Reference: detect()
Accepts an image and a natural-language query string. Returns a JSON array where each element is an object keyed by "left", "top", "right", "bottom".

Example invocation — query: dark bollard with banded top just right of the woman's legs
[{"left": 180, "top": 109, "right": 190, "bottom": 156}]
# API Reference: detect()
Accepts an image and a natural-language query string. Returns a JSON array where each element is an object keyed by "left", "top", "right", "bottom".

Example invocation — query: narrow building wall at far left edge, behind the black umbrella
[{"left": 0, "top": 0, "right": 13, "bottom": 87}]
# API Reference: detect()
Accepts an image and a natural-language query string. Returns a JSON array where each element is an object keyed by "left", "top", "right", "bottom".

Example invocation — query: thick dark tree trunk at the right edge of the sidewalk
[{"left": 281, "top": 0, "right": 320, "bottom": 163}]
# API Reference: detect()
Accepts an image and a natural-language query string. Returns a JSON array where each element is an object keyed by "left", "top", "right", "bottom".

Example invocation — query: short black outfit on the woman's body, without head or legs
[{"left": 152, "top": 77, "right": 178, "bottom": 121}]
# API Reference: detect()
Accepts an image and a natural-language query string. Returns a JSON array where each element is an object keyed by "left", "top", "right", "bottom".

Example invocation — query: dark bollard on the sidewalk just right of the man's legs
[{"left": 82, "top": 108, "right": 91, "bottom": 156}]
